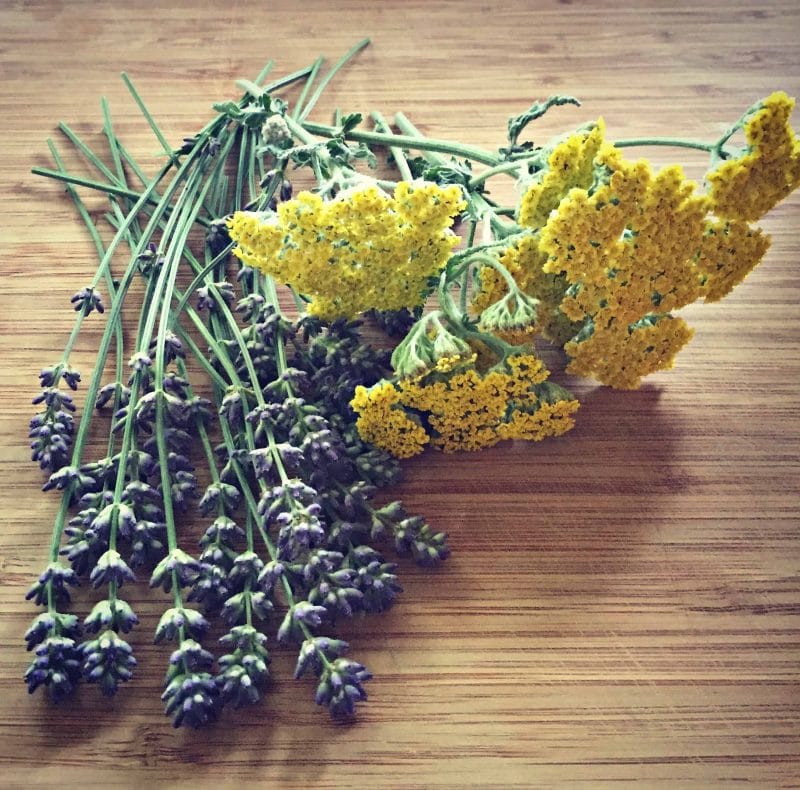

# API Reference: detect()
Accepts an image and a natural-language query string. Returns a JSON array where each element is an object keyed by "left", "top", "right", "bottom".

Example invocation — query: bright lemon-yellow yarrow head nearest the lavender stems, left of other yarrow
[{"left": 228, "top": 180, "right": 466, "bottom": 320}]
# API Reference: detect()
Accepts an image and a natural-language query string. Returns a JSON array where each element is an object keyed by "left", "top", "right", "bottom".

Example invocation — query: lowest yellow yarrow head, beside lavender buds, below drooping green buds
[{"left": 351, "top": 354, "right": 578, "bottom": 457}]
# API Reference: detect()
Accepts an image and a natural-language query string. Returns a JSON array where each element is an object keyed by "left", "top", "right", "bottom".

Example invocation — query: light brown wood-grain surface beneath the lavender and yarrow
[{"left": 0, "top": 0, "right": 800, "bottom": 788}]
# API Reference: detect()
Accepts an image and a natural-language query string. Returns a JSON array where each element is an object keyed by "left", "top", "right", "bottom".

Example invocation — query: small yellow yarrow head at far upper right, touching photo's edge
[{"left": 706, "top": 91, "right": 800, "bottom": 220}]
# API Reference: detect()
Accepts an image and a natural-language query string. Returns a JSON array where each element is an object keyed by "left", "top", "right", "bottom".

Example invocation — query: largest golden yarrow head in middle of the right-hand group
[{"left": 540, "top": 145, "right": 707, "bottom": 325}]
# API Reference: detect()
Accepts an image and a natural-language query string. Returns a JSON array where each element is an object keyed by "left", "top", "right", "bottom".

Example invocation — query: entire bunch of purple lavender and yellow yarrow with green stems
[{"left": 25, "top": 42, "right": 800, "bottom": 727}]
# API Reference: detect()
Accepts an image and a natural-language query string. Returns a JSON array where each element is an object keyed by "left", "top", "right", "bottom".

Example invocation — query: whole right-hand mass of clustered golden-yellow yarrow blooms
[{"left": 474, "top": 94, "right": 800, "bottom": 389}]
